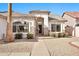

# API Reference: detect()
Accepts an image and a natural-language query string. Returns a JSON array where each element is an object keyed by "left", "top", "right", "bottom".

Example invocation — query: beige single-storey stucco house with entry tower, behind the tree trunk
[{"left": 0, "top": 10, "right": 66, "bottom": 39}]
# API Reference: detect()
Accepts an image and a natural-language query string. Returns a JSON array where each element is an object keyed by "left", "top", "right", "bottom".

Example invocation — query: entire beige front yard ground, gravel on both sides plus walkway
[{"left": 0, "top": 37, "right": 79, "bottom": 56}]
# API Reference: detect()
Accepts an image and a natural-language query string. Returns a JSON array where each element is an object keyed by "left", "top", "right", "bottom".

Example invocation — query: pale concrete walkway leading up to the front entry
[{"left": 31, "top": 40, "right": 49, "bottom": 56}]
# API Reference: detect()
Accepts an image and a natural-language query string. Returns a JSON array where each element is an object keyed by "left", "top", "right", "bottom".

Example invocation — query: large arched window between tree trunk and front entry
[{"left": 13, "top": 22, "right": 29, "bottom": 32}]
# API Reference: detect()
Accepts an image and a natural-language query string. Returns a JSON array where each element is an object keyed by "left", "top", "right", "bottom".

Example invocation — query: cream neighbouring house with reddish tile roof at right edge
[{"left": 62, "top": 12, "right": 79, "bottom": 37}]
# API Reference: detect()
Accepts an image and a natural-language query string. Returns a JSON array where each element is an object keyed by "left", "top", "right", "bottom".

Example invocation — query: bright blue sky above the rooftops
[{"left": 0, "top": 3, "right": 79, "bottom": 15}]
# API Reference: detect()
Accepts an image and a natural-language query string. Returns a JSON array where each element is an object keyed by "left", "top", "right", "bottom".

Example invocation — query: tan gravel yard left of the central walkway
[{"left": 0, "top": 40, "right": 34, "bottom": 56}]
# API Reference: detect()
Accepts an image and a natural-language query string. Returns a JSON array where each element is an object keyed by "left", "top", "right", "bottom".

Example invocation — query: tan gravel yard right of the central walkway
[{"left": 44, "top": 38, "right": 79, "bottom": 56}]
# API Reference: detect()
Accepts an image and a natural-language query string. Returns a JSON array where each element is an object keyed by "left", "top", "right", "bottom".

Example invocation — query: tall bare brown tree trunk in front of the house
[{"left": 6, "top": 3, "right": 14, "bottom": 42}]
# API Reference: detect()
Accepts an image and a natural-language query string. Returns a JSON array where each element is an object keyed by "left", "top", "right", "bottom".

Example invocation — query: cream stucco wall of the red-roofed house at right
[{"left": 63, "top": 14, "right": 76, "bottom": 36}]
